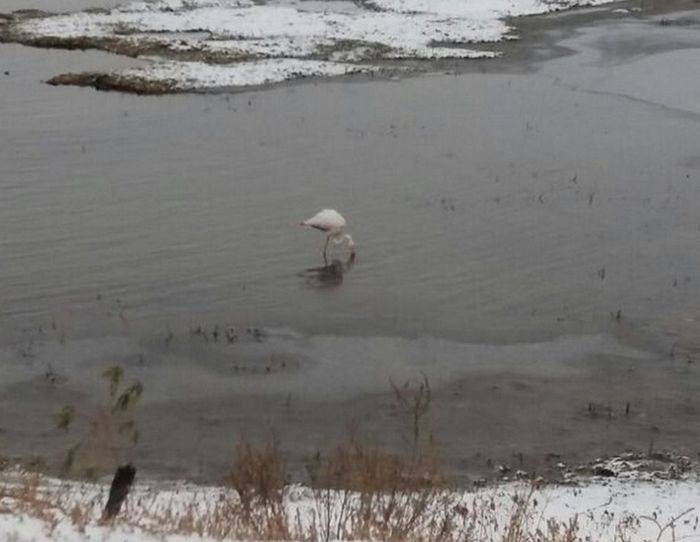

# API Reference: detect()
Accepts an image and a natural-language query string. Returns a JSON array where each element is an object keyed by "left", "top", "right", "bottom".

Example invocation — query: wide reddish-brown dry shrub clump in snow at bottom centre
[{"left": 307, "top": 443, "right": 457, "bottom": 540}]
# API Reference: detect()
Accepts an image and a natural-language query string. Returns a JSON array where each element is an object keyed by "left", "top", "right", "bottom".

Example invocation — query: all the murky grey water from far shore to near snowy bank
[{"left": 0, "top": 3, "right": 700, "bottom": 477}]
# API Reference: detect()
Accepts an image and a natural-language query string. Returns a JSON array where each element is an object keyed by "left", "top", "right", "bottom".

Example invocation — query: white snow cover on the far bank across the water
[{"left": 0, "top": 0, "right": 610, "bottom": 91}]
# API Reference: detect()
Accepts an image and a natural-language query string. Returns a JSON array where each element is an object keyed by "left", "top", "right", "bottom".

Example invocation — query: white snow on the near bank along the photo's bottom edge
[{"left": 0, "top": 473, "right": 700, "bottom": 542}]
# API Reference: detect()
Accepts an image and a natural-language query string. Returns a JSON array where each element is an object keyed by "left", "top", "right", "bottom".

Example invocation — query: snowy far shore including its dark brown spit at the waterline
[{"left": 0, "top": 0, "right": 637, "bottom": 95}]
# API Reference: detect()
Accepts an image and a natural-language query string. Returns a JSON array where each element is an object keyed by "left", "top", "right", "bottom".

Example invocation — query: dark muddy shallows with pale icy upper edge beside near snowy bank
[{"left": 0, "top": 330, "right": 698, "bottom": 484}]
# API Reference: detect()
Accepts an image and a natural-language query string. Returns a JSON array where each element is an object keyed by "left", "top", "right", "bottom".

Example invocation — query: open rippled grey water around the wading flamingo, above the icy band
[{"left": 0, "top": 13, "right": 700, "bottom": 342}]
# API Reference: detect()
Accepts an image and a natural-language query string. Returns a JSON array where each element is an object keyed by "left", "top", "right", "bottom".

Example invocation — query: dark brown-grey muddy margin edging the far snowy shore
[{"left": 0, "top": 0, "right": 694, "bottom": 96}]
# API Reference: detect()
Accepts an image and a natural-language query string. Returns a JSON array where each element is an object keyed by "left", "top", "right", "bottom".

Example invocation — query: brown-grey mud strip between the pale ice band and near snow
[{"left": 0, "top": 336, "right": 700, "bottom": 485}]
